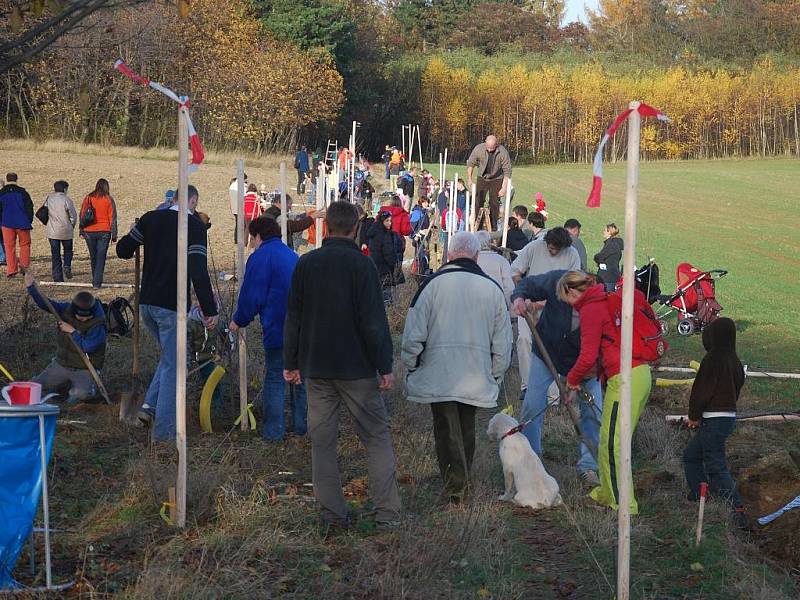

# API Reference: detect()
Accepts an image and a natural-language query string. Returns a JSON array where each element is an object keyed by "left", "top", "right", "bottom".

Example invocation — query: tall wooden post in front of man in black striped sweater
[{"left": 175, "top": 106, "right": 189, "bottom": 527}]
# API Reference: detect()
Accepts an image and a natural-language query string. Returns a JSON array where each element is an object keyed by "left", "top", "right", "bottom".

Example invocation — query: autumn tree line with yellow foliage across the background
[{"left": 0, "top": 0, "right": 800, "bottom": 162}]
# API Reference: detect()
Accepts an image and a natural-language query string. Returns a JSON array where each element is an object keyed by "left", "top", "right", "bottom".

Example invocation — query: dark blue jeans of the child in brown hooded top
[{"left": 683, "top": 417, "right": 742, "bottom": 508}]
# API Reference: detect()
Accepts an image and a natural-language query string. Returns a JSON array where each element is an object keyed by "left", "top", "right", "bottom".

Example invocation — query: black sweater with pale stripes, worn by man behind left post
[{"left": 117, "top": 210, "right": 217, "bottom": 317}]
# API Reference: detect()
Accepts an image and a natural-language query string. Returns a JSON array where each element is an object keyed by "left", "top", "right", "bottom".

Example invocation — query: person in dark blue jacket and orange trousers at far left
[{"left": 0, "top": 173, "right": 33, "bottom": 277}]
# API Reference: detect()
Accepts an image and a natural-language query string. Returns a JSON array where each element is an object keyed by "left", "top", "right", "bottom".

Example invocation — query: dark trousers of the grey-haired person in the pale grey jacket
[{"left": 431, "top": 402, "right": 476, "bottom": 498}]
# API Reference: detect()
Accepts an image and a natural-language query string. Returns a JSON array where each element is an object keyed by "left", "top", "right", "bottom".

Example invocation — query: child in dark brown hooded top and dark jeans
[{"left": 683, "top": 317, "right": 749, "bottom": 528}]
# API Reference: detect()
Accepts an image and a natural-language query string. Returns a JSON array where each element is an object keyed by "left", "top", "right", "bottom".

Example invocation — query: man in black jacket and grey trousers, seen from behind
[{"left": 283, "top": 202, "right": 400, "bottom": 527}]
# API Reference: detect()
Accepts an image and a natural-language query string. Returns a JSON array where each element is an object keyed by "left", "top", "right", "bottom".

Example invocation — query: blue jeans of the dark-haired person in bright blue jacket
[{"left": 261, "top": 348, "right": 308, "bottom": 442}]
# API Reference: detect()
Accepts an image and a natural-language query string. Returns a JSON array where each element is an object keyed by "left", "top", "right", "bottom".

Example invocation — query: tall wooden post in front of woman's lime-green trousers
[{"left": 617, "top": 102, "right": 642, "bottom": 600}]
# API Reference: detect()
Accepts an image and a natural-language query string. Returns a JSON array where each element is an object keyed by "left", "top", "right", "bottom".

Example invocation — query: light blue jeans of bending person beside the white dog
[{"left": 521, "top": 353, "right": 603, "bottom": 473}]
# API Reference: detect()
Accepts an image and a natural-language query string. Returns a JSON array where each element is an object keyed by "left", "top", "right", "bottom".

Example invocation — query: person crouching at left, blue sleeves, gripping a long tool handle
[{"left": 25, "top": 271, "right": 108, "bottom": 404}]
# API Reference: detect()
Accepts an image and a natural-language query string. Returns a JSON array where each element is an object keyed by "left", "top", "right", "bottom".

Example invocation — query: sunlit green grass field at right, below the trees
[{"left": 449, "top": 159, "right": 800, "bottom": 370}]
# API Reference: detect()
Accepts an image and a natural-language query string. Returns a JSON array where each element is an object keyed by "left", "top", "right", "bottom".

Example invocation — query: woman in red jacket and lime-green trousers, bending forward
[{"left": 558, "top": 271, "right": 652, "bottom": 514}]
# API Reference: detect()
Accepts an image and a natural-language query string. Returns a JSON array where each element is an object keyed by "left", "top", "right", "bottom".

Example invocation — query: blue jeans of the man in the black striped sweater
[{"left": 139, "top": 304, "right": 178, "bottom": 440}]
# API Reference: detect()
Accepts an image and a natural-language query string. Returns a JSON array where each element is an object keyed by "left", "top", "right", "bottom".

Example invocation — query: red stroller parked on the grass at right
[{"left": 658, "top": 263, "right": 728, "bottom": 335}]
